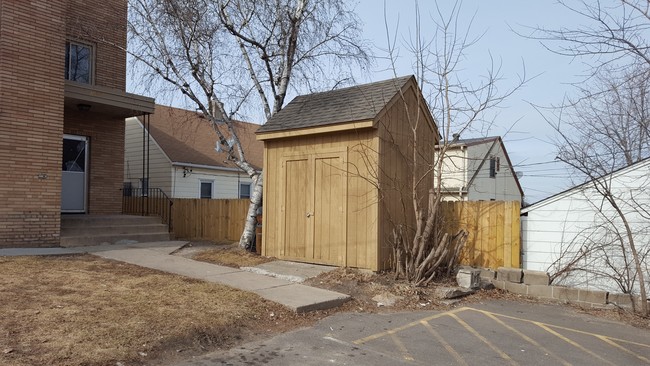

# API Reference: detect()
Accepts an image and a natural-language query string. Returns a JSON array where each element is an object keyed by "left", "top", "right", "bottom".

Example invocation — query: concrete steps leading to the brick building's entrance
[{"left": 60, "top": 215, "right": 169, "bottom": 247}]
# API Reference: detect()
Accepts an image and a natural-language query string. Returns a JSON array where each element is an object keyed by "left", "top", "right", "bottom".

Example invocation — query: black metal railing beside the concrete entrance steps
[{"left": 122, "top": 187, "right": 174, "bottom": 233}]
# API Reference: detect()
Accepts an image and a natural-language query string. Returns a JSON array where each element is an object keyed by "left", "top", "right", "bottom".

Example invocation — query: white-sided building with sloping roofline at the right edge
[{"left": 521, "top": 159, "right": 650, "bottom": 293}]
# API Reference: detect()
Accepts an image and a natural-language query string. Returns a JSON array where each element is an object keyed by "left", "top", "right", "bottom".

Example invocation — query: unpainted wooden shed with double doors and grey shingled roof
[{"left": 257, "top": 76, "right": 439, "bottom": 271}]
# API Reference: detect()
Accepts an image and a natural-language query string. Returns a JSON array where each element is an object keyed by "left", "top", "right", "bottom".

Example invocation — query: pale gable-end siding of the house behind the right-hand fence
[{"left": 468, "top": 141, "right": 522, "bottom": 202}]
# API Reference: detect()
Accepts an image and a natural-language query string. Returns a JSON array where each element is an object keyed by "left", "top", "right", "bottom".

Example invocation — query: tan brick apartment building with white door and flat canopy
[{"left": 0, "top": 0, "right": 154, "bottom": 247}]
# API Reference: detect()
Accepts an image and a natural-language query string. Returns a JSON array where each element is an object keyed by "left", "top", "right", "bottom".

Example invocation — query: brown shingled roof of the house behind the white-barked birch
[{"left": 139, "top": 105, "right": 264, "bottom": 170}]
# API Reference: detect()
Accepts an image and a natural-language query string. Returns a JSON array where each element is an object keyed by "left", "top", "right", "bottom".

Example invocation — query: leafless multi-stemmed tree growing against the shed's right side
[{"left": 382, "top": 2, "right": 526, "bottom": 285}]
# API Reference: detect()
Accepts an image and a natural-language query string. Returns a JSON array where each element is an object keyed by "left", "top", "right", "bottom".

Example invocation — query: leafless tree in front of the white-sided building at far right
[{"left": 536, "top": 67, "right": 650, "bottom": 314}]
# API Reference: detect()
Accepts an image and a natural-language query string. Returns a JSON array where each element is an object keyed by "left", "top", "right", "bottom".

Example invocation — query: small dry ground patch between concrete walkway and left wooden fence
[{"left": 176, "top": 241, "right": 277, "bottom": 268}]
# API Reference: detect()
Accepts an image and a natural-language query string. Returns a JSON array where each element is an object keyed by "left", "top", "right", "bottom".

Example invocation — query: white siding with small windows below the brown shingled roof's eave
[{"left": 171, "top": 166, "right": 252, "bottom": 198}]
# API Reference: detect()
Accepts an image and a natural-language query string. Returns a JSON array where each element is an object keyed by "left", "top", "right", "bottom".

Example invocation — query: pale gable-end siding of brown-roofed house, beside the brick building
[{"left": 124, "top": 118, "right": 172, "bottom": 197}]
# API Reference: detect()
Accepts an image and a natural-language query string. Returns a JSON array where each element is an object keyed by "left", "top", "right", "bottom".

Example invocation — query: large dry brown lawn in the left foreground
[{"left": 0, "top": 256, "right": 313, "bottom": 366}]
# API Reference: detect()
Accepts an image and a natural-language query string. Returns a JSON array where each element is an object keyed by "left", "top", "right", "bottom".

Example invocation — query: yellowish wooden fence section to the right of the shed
[{"left": 442, "top": 201, "right": 521, "bottom": 269}]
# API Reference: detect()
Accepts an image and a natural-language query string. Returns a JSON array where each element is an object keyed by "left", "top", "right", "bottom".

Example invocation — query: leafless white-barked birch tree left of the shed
[{"left": 129, "top": 0, "right": 369, "bottom": 248}]
